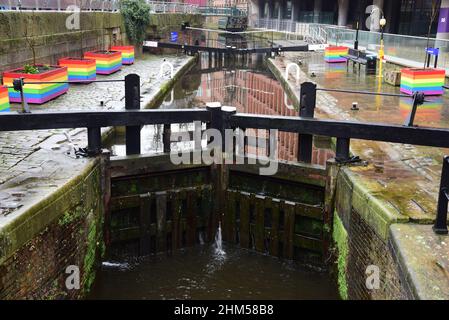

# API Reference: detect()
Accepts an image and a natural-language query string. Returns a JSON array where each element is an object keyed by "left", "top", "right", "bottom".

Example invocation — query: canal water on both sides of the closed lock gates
[{"left": 96, "top": 42, "right": 338, "bottom": 300}]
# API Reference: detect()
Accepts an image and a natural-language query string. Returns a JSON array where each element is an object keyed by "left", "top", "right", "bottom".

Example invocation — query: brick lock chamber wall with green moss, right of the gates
[{"left": 333, "top": 170, "right": 413, "bottom": 300}]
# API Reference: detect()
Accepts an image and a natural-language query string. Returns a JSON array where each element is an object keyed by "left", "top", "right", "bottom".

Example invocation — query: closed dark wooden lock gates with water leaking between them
[{"left": 105, "top": 154, "right": 332, "bottom": 270}]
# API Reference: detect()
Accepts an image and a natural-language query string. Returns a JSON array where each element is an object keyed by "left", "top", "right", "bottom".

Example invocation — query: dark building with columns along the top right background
[{"left": 248, "top": 0, "right": 449, "bottom": 39}]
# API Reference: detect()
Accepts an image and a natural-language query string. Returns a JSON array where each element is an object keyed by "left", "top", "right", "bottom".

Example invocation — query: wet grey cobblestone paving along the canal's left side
[{"left": 0, "top": 55, "right": 191, "bottom": 221}]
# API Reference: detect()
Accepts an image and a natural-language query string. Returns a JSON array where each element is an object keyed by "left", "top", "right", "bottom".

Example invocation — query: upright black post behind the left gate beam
[{"left": 125, "top": 74, "right": 141, "bottom": 155}]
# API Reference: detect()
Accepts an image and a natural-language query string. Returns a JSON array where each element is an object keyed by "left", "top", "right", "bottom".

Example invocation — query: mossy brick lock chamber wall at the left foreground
[{"left": 0, "top": 160, "right": 104, "bottom": 300}]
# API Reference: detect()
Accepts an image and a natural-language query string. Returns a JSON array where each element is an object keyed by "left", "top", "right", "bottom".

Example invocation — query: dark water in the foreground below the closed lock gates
[{"left": 90, "top": 245, "right": 338, "bottom": 300}]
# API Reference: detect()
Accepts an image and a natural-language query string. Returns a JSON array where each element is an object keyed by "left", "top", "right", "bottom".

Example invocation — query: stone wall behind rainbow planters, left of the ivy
[{"left": 0, "top": 12, "right": 126, "bottom": 72}]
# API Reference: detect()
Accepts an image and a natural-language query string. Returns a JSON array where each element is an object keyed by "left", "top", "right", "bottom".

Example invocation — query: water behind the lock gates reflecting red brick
[{"left": 107, "top": 50, "right": 334, "bottom": 165}]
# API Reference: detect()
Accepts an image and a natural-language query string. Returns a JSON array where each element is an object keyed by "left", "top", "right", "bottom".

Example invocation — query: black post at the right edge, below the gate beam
[{"left": 433, "top": 156, "right": 449, "bottom": 234}]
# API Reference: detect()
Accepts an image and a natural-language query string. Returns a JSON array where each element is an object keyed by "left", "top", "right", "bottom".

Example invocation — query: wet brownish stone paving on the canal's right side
[{"left": 275, "top": 53, "right": 449, "bottom": 223}]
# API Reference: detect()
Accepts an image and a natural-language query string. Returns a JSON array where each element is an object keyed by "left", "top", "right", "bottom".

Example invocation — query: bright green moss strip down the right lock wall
[{"left": 332, "top": 212, "right": 349, "bottom": 300}]
